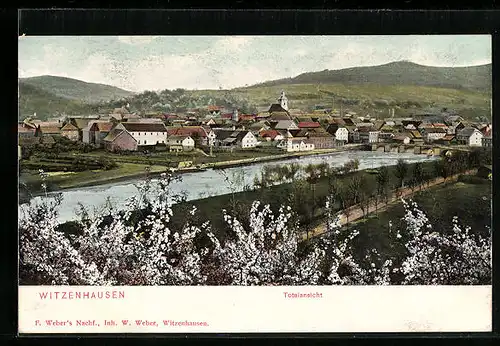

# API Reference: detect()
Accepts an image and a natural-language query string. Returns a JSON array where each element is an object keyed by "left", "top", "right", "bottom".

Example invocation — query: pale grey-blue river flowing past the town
[{"left": 19, "top": 151, "right": 438, "bottom": 222}]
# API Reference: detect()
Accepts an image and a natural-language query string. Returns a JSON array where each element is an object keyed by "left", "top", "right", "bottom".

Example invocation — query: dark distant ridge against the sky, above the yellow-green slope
[{"left": 254, "top": 61, "right": 492, "bottom": 91}]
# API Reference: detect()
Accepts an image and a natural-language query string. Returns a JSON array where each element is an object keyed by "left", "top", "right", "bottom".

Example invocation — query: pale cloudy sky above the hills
[{"left": 18, "top": 35, "right": 491, "bottom": 92}]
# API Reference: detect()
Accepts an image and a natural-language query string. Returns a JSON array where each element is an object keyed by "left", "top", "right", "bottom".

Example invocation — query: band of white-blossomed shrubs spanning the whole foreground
[{"left": 19, "top": 172, "right": 491, "bottom": 285}]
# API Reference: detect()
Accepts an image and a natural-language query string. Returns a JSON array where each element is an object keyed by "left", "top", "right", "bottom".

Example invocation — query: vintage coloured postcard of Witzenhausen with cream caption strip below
[{"left": 18, "top": 35, "right": 493, "bottom": 334}]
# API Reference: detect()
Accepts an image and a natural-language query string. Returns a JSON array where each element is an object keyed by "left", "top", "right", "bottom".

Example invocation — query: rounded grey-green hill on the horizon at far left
[{"left": 20, "top": 76, "right": 133, "bottom": 103}]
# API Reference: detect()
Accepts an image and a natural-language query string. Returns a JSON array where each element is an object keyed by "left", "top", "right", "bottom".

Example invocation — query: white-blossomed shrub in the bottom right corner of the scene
[{"left": 396, "top": 200, "right": 492, "bottom": 285}]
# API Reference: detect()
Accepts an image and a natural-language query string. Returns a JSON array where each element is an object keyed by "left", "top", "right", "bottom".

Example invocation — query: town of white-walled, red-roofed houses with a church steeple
[{"left": 18, "top": 91, "right": 492, "bottom": 158}]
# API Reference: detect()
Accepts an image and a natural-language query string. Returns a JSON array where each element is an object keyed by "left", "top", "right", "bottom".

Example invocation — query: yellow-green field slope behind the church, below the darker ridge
[{"left": 189, "top": 83, "right": 491, "bottom": 120}]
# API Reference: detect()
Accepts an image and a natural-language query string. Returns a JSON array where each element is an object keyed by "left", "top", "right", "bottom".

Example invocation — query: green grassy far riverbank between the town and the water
[{"left": 20, "top": 145, "right": 363, "bottom": 200}]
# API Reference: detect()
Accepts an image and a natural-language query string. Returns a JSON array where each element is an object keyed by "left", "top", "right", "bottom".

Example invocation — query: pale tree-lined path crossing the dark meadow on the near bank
[{"left": 303, "top": 169, "right": 477, "bottom": 240}]
